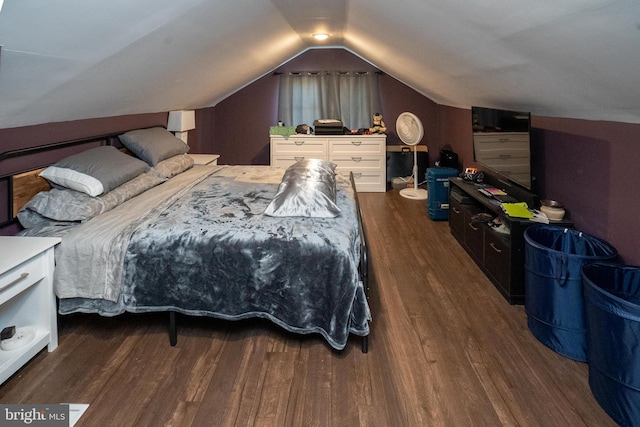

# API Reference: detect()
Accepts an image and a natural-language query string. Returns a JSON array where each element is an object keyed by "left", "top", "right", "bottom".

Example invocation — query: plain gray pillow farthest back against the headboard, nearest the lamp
[{"left": 118, "top": 127, "right": 189, "bottom": 166}]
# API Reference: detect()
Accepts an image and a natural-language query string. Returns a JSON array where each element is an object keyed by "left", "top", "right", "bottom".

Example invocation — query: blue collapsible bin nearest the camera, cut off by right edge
[{"left": 582, "top": 263, "right": 640, "bottom": 426}]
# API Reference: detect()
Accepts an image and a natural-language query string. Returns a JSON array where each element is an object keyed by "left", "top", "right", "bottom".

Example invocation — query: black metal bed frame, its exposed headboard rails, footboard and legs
[{"left": 0, "top": 132, "right": 370, "bottom": 353}]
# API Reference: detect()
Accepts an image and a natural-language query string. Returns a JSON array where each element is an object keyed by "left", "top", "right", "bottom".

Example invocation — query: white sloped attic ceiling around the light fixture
[{"left": 0, "top": 0, "right": 640, "bottom": 128}]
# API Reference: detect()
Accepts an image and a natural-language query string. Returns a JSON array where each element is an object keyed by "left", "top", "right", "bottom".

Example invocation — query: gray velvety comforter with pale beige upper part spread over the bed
[{"left": 33, "top": 166, "right": 369, "bottom": 349}]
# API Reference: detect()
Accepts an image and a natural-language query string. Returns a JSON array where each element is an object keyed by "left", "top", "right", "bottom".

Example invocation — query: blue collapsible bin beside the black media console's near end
[{"left": 524, "top": 224, "right": 618, "bottom": 362}]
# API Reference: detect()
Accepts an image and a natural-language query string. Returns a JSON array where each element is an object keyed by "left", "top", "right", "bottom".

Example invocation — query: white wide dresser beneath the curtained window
[{"left": 271, "top": 135, "right": 387, "bottom": 192}]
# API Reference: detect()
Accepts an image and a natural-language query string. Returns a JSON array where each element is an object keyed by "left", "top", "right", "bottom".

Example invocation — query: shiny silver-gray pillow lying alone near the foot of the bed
[{"left": 264, "top": 159, "right": 340, "bottom": 218}]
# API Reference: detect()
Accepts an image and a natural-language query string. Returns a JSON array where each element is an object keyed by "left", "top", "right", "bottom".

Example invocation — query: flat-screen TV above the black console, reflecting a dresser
[{"left": 471, "top": 107, "right": 532, "bottom": 190}]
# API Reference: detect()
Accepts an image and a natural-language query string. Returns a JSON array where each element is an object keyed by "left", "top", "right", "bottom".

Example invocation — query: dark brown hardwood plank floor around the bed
[{"left": 0, "top": 191, "right": 615, "bottom": 426}]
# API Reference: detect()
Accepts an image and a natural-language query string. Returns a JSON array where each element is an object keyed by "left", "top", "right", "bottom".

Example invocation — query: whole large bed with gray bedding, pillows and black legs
[{"left": 0, "top": 128, "right": 371, "bottom": 352}]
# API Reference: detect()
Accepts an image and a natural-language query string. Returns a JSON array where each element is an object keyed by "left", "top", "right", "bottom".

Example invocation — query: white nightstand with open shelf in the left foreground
[{"left": 0, "top": 236, "right": 60, "bottom": 384}]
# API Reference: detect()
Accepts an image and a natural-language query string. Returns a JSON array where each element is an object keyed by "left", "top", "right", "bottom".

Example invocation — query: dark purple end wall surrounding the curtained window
[{"left": 189, "top": 49, "right": 437, "bottom": 165}]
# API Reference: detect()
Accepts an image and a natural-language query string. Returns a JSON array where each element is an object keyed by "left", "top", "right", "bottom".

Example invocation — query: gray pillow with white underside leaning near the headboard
[{"left": 40, "top": 145, "right": 148, "bottom": 196}]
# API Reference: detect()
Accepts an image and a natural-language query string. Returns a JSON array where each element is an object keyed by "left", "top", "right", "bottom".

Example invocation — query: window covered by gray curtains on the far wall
[{"left": 278, "top": 71, "right": 380, "bottom": 129}]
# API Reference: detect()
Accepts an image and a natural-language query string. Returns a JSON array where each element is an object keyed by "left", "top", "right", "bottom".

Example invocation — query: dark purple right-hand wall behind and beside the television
[{"left": 440, "top": 106, "right": 640, "bottom": 266}]
